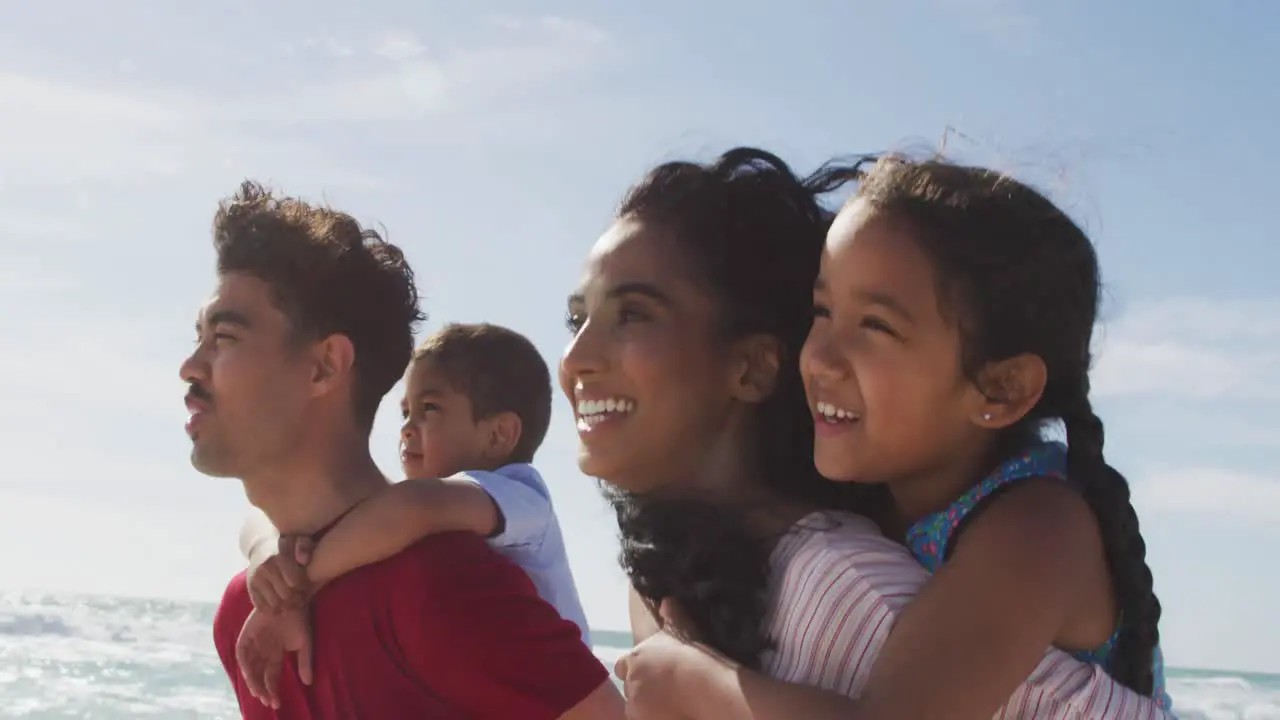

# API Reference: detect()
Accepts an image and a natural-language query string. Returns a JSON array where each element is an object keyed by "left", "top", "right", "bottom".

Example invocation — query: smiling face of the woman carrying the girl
[{"left": 559, "top": 217, "right": 733, "bottom": 493}]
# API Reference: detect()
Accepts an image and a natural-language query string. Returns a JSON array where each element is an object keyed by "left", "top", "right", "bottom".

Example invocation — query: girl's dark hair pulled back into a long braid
[{"left": 858, "top": 156, "right": 1160, "bottom": 696}]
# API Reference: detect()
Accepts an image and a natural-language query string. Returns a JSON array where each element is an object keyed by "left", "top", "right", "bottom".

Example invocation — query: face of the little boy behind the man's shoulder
[{"left": 401, "top": 359, "right": 492, "bottom": 478}]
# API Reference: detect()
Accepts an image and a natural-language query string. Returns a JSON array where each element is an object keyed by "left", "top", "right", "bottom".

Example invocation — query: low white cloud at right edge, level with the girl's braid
[{"left": 1133, "top": 466, "right": 1280, "bottom": 523}]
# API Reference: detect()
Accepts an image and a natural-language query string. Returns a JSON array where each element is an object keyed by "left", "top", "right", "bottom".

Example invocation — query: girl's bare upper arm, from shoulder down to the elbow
[{"left": 860, "top": 479, "right": 1106, "bottom": 720}]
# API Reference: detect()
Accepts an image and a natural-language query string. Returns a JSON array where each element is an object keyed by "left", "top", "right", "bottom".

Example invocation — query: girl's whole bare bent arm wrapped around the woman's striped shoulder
[{"left": 672, "top": 480, "right": 1102, "bottom": 720}]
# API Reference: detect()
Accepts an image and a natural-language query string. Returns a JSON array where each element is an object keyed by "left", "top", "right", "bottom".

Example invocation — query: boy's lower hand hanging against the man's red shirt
[{"left": 236, "top": 609, "right": 311, "bottom": 708}]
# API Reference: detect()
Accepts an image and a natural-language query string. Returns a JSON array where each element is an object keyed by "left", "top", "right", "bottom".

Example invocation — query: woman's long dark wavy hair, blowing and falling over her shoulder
[{"left": 604, "top": 147, "right": 861, "bottom": 667}]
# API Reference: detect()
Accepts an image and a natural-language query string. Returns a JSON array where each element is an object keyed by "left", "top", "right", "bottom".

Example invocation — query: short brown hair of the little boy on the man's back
[{"left": 413, "top": 323, "right": 552, "bottom": 462}]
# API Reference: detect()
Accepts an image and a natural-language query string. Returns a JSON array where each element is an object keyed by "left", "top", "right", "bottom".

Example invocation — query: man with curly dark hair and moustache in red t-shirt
[{"left": 182, "top": 182, "right": 623, "bottom": 719}]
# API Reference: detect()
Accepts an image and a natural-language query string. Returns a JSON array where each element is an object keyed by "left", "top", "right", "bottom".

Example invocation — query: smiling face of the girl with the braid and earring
[{"left": 800, "top": 200, "right": 983, "bottom": 484}]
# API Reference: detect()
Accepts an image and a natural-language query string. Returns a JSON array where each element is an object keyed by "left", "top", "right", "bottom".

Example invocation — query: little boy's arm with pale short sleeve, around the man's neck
[{"left": 307, "top": 473, "right": 552, "bottom": 587}]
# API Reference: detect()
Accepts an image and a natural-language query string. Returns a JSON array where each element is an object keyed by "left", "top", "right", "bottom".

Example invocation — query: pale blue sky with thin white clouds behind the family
[{"left": 0, "top": 0, "right": 1280, "bottom": 671}]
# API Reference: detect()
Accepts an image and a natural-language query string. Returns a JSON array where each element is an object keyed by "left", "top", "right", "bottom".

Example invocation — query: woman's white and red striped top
[{"left": 763, "top": 512, "right": 1172, "bottom": 720}]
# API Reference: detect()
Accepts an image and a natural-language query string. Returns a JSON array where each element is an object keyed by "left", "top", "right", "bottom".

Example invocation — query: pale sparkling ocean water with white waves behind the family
[{"left": 0, "top": 592, "right": 1280, "bottom": 720}]
